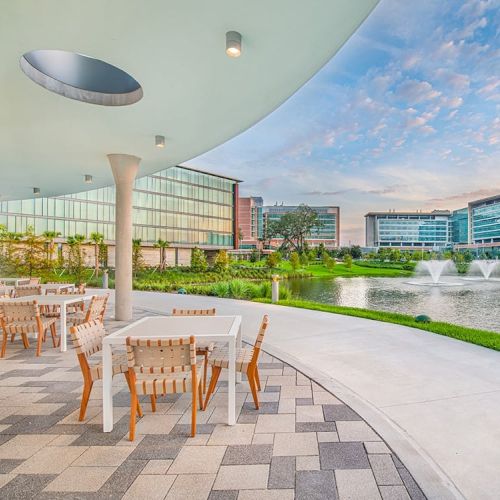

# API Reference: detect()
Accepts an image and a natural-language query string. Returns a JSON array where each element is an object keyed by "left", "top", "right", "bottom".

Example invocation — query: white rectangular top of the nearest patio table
[{"left": 104, "top": 316, "right": 241, "bottom": 344}]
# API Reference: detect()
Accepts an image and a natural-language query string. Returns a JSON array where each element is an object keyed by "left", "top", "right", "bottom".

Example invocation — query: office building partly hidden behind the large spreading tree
[{"left": 264, "top": 205, "right": 340, "bottom": 249}]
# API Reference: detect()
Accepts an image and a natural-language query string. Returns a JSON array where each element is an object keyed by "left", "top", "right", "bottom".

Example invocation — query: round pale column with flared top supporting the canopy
[{"left": 108, "top": 154, "right": 141, "bottom": 321}]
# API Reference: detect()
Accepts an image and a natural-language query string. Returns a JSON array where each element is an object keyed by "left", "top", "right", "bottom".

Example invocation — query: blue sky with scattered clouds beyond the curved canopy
[{"left": 188, "top": 0, "right": 500, "bottom": 245}]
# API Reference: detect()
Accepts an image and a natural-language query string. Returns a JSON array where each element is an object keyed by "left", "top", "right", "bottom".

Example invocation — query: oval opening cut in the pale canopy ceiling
[{"left": 20, "top": 50, "right": 143, "bottom": 106}]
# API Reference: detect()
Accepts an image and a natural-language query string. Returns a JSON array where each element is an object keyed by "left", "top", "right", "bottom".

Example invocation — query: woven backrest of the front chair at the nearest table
[{"left": 126, "top": 336, "right": 196, "bottom": 373}]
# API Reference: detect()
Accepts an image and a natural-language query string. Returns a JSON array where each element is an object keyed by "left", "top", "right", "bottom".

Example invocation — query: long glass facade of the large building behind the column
[{"left": 0, "top": 166, "right": 238, "bottom": 249}]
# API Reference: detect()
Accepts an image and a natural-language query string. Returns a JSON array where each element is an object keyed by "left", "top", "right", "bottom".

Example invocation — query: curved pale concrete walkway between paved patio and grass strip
[{"left": 119, "top": 292, "right": 500, "bottom": 500}]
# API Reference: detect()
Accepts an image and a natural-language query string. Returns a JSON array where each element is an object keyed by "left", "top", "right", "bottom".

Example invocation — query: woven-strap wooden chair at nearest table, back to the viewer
[{"left": 126, "top": 336, "right": 203, "bottom": 441}]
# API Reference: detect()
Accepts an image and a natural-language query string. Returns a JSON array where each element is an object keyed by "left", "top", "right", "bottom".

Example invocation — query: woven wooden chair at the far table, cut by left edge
[{"left": 0, "top": 300, "right": 60, "bottom": 358}]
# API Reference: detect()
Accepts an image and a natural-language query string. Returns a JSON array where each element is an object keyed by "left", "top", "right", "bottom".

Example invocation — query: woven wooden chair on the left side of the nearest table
[{"left": 70, "top": 320, "right": 142, "bottom": 422}]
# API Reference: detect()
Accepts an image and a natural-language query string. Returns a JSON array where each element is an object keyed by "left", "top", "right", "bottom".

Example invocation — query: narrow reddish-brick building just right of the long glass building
[{"left": 238, "top": 196, "right": 264, "bottom": 250}]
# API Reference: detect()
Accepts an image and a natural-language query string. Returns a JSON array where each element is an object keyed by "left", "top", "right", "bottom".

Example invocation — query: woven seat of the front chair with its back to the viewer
[{"left": 135, "top": 365, "right": 203, "bottom": 394}]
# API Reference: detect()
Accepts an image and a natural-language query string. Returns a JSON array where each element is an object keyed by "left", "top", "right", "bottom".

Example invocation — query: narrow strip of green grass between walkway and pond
[{"left": 255, "top": 299, "right": 500, "bottom": 351}]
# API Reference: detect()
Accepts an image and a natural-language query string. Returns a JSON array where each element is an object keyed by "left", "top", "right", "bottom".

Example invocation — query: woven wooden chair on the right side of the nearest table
[{"left": 203, "top": 314, "right": 269, "bottom": 410}]
